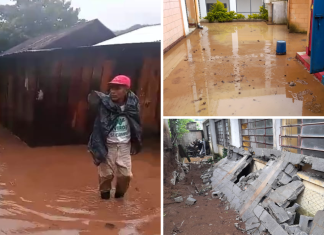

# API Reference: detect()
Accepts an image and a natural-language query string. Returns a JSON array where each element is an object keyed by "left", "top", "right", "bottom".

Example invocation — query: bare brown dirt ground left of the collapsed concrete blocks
[{"left": 163, "top": 159, "right": 245, "bottom": 235}]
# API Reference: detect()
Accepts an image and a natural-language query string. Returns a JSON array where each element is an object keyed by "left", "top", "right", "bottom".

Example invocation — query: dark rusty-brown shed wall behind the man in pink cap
[{"left": 0, "top": 43, "right": 161, "bottom": 146}]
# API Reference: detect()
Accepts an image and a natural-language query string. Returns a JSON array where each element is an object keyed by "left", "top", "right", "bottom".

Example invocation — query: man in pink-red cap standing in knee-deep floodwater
[{"left": 88, "top": 75, "right": 142, "bottom": 200}]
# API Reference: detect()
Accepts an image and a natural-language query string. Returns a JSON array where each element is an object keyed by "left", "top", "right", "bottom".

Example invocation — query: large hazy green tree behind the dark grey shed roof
[{"left": 0, "top": 0, "right": 85, "bottom": 51}]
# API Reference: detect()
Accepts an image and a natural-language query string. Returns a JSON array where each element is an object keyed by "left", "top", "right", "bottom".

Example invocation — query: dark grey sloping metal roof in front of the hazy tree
[{"left": 1, "top": 19, "right": 115, "bottom": 56}]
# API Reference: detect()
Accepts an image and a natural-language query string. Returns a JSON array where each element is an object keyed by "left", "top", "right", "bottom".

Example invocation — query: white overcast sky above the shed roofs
[{"left": 0, "top": 0, "right": 163, "bottom": 30}]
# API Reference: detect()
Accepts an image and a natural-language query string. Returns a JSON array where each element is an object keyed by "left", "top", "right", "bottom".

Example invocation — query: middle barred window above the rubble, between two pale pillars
[{"left": 240, "top": 119, "right": 273, "bottom": 150}]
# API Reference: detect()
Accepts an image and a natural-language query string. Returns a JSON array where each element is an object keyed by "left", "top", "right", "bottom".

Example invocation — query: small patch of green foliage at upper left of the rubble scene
[{"left": 169, "top": 119, "right": 194, "bottom": 146}]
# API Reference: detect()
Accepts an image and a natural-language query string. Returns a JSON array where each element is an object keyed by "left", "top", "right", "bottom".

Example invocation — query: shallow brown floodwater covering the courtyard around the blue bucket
[{"left": 164, "top": 22, "right": 324, "bottom": 116}]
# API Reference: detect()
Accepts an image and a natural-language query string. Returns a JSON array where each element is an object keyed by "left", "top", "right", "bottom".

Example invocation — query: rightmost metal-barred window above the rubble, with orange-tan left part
[{"left": 280, "top": 119, "right": 324, "bottom": 158}]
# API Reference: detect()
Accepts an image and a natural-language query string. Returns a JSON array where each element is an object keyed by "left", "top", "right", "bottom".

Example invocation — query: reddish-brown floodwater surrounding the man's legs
[{"left": 0, "top": 128, "right": 161, "bottom": 235}]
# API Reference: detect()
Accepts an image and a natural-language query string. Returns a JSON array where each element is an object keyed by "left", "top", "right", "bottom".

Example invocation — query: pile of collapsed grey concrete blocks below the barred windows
[{"left": 209, "top": 147, "right": 324, "bottom": 235}]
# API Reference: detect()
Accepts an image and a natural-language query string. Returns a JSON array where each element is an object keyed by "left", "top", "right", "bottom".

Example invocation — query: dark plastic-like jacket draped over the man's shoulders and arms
[{"left": 88, "top": 91, "right": 142, "bottom": 166}]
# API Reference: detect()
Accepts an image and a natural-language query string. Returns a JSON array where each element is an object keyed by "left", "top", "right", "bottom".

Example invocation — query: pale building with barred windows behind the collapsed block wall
[{"left": 204, "top": 119, "right": 324, "bottom": 216}]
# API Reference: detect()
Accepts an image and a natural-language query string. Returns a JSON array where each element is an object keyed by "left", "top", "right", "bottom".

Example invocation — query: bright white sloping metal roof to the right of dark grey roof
[{"left": 96, "top": 25, "right": 162, "bottom": 46}]
